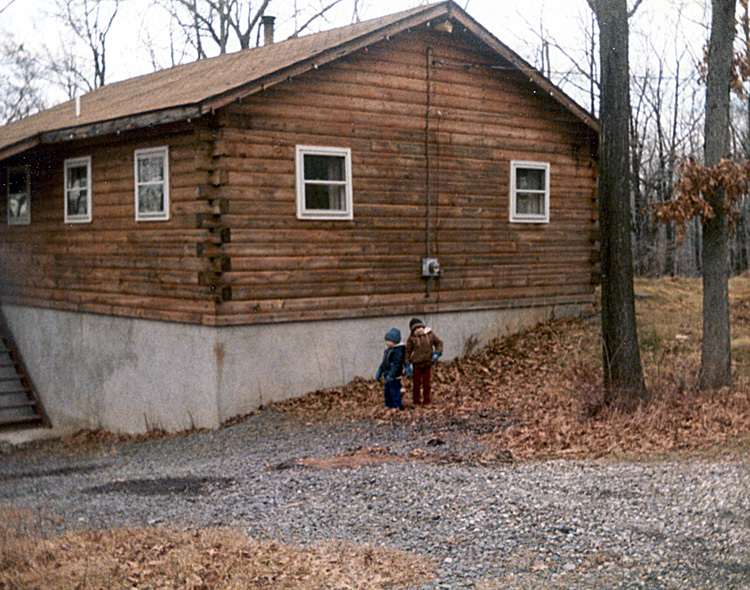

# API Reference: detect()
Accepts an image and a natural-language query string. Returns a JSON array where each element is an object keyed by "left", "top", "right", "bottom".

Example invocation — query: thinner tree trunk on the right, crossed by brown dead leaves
[{"left": 700, "top": 0, "right": 736, "bottom": 388}]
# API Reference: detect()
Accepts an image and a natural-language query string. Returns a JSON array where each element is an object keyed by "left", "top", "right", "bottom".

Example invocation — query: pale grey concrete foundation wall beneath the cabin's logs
[{"left": 3, "top": 304, "right": 590, "bottom": 434}]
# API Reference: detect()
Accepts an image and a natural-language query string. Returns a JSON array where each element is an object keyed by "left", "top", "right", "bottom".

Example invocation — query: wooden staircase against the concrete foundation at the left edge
[{"left": 0, "top": 313, "right": 51, "bottom": 430}]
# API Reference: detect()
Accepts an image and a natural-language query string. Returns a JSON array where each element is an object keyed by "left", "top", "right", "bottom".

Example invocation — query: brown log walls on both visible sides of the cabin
[{"left": 0, "top": 26, "right": 596, "bottom": 325}]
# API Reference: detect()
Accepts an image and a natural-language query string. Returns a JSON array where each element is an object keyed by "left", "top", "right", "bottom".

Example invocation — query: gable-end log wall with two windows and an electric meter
[{"left": 213, "top": 32, "right": 596, "bottom": 324}]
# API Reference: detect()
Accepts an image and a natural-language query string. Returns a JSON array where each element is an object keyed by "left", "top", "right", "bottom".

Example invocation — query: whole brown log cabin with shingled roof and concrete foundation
[{"left": 0, "top": 1, "right": 598, "bottom": 433}]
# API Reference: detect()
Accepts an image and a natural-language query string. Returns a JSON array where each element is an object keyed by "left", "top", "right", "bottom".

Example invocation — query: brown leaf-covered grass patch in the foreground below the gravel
[{"left": 0, "top": 508, "right": 432, "bottom": 590}]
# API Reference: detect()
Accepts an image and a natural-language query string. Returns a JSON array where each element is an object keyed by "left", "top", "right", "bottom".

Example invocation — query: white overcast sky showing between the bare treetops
[{"left": 0, "top": 0, "right": 710, "bottom": 106}]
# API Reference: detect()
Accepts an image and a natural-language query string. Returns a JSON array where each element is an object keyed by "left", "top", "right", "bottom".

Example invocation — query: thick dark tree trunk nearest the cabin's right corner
[{"left": 592, "top": 0, "right": 646, "bottom": 406}]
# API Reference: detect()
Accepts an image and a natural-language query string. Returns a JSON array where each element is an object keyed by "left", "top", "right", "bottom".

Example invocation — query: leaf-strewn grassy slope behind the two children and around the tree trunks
[{"left": 279, "top": 276, "right": 750, "bottom": 460}]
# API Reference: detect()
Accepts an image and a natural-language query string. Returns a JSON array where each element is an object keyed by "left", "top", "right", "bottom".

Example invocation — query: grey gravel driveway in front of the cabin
[{"left": 0, "top": 410, "right": 750, "bottom": 590}]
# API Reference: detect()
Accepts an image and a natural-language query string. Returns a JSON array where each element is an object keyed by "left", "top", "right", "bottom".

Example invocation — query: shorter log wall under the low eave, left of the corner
[{"left": 0, "top": 128, "right": 222, "bottom": 323}]
